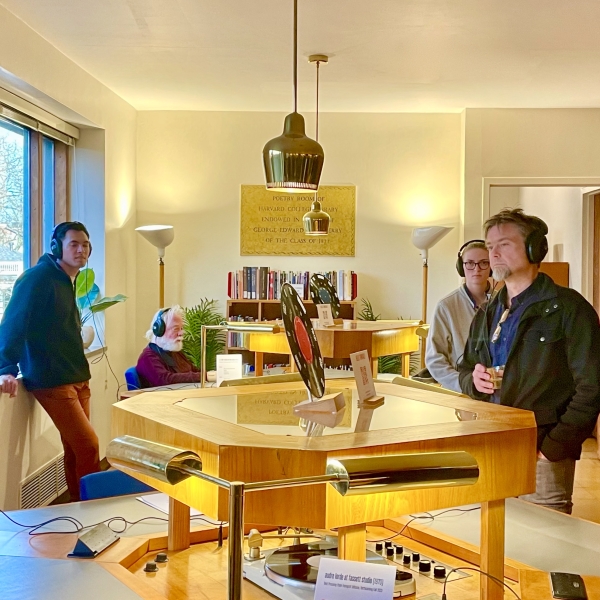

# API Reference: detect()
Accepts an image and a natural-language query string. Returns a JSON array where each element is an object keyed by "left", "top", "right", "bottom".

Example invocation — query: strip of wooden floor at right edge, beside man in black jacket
[{"left": 573, "top": 438, "right": 600, "bottom": 523}]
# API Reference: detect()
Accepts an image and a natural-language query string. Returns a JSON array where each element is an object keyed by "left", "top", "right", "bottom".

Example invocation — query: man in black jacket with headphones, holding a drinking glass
[{"left": 460, "top": 209, "right": 600, "bottom": 514}]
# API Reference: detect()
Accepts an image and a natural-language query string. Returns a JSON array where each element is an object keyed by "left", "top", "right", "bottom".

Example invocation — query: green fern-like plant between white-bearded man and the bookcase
[{"left": 183, "top": 298, "right": 227, "bottom": 371}]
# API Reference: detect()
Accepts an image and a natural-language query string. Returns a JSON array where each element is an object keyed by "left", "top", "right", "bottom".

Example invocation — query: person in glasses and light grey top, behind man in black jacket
[{"left": 425, "top": 240, "right": 491, "bottom": 392}]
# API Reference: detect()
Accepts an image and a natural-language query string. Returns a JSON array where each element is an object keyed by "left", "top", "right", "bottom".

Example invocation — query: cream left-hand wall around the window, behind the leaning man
[{"left": 0, "top": 6, "right": 136, "bottom": 506}]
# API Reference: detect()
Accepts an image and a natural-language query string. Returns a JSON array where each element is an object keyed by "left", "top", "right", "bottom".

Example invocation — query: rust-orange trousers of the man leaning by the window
[{"left": 32, "top": 381, "right": 100, "bottom": 502}]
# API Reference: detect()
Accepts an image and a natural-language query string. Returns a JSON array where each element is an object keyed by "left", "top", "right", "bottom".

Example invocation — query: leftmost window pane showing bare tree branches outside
[{"left": 0, "top": 121, "right": 27, "bottom": 317}]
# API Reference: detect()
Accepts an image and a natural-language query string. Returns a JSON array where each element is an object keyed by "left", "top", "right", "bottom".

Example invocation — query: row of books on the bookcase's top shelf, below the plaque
[{"left": 227, "top": 267, "right": 358, "bottom": 300}]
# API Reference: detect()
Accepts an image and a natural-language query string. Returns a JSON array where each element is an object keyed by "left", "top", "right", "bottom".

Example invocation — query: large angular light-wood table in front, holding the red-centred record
[{"left": 112, "top": 380, "right": 536, "bottom": 600}]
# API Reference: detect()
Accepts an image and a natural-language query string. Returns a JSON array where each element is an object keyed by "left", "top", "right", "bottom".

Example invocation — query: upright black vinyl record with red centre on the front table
[{"left": 281, "top": 283, "right": 325, "bottom": 398}]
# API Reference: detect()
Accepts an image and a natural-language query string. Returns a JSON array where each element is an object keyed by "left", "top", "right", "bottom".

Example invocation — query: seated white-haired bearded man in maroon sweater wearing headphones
[{"left": 135, "top": 305, "right": 200, "bottom": 388}]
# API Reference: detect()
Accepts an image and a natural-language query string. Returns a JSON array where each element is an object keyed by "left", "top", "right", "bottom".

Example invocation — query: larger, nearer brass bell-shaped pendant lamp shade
[{"left": 263, "top": 112, "right": 325, "bottom": 192}]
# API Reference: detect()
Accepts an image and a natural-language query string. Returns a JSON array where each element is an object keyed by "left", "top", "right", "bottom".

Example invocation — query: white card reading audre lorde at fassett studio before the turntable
[{"left": 315, "top": 557, "right": 396, "bottom": 600}]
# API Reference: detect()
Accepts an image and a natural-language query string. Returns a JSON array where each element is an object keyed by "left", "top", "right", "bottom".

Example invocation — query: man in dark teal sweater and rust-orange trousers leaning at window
[{"left": 0, "top": 221, "right": 99, "bottom": 501}]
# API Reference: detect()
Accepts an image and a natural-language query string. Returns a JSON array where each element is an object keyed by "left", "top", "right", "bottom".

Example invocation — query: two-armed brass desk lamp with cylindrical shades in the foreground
[{"left": 106, "top": 435, "right": 479, "bottom": 600}]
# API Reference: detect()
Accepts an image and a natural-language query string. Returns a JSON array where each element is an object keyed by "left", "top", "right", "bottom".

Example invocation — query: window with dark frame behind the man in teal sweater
[{"left": 0, "top": 112, "right": 69, "bottom": 318}]
